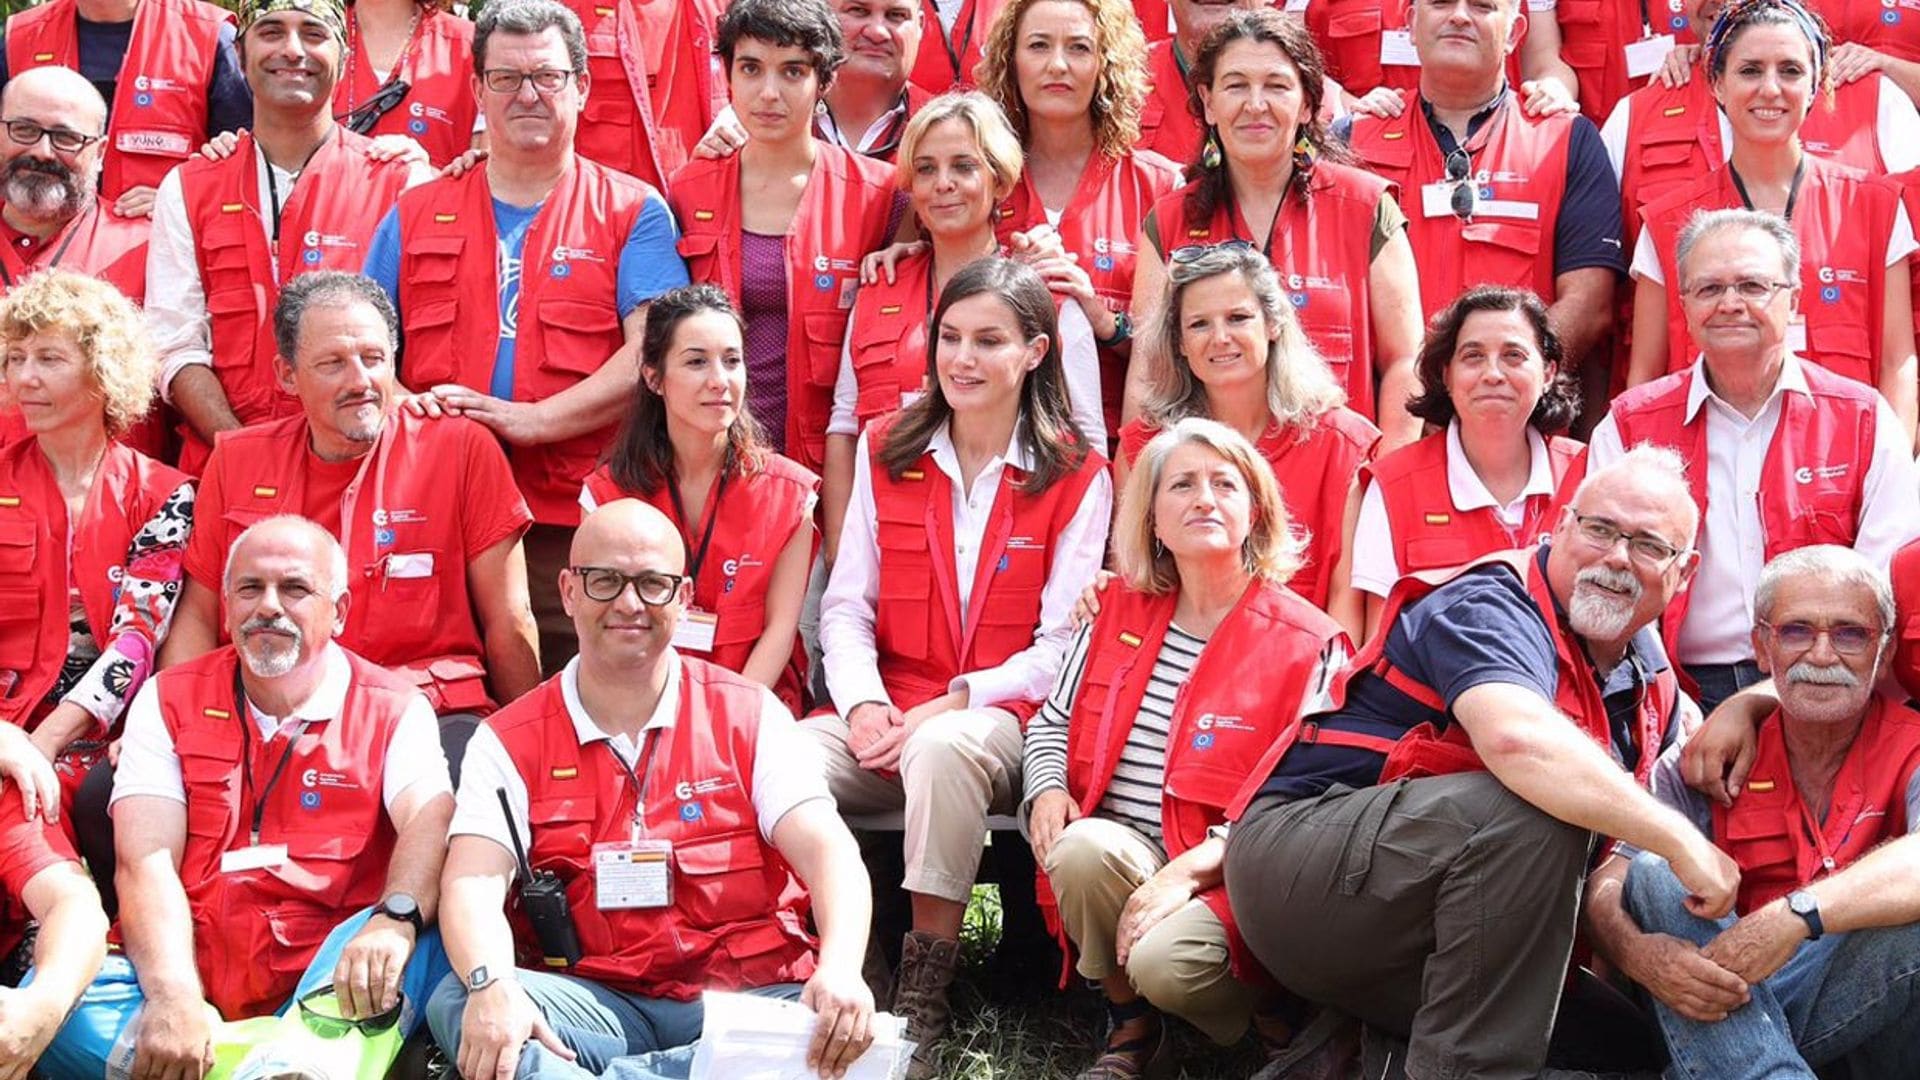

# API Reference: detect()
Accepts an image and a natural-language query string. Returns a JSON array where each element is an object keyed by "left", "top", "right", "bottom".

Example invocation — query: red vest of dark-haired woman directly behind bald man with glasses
[{"left": 586, "top": 454, "right": 820, "bottom": 715}]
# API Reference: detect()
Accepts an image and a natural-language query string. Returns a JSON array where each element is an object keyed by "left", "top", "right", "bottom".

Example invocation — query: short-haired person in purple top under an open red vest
[{"left": 666, "top": 0, "right": 904, "bottom": 471}]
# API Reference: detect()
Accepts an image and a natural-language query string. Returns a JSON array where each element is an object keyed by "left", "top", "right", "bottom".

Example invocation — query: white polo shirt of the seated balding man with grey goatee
[{"left": 109, "top": 642, "right": 453, "bottom": 815}]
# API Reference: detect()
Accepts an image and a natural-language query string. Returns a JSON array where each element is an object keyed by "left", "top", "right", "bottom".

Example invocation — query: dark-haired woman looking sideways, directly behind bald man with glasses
[{"left": 580, "top": 284, "right": 820, "bottom": 713}]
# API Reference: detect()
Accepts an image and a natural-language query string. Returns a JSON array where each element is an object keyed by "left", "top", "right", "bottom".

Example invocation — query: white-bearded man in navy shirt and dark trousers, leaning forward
[{"left": 1227, "top": 448, "right": 1738, "bottom": 1080}]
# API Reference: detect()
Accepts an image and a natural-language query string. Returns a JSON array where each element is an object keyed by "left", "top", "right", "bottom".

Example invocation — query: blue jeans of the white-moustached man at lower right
[{"left": 1626, "top": 853, "right": 1920, "bottom": 1080}]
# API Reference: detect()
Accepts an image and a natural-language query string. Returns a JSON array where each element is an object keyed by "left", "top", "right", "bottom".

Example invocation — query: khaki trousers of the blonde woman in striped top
[{"left": 1044, "top": 817, "right": 1260, "bottom": 1045}]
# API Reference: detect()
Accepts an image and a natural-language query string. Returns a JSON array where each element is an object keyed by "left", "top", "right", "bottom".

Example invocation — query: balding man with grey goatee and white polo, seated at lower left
[{"left": 44, "top": 517, "right": 453, "bottom": 1076}]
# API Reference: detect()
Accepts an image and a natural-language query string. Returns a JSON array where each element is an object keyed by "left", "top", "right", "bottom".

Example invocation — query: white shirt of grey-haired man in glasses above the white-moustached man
[{"left": 1586, "top": 354, "right": 1920, "bottom": 665}]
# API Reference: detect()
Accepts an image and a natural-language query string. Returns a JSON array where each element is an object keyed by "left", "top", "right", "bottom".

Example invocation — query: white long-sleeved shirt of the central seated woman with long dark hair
[{"left": 820, "top": 419, "right": 1114, "bottom": 717}]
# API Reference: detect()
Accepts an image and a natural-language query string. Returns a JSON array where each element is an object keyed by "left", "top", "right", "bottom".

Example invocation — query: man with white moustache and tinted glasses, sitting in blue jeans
[{"left": 1588, "top": 544, "right": 1920, "bottom": 1078}]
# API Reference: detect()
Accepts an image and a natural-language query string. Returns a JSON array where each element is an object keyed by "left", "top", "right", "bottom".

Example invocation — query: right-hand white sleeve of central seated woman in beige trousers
[{"left": 950, "top": 469, "right": 1114, "bottom": 709}]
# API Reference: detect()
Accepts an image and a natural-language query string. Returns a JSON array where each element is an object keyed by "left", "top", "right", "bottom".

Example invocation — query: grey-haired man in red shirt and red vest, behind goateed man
[{"left": 161, "top": 271, "right": 540, "bottom": 776}]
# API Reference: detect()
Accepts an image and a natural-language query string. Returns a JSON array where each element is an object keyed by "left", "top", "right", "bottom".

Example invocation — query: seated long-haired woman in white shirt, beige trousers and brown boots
[{"left": 806, "top": 258, "right": 1112, "bottom": 1080}]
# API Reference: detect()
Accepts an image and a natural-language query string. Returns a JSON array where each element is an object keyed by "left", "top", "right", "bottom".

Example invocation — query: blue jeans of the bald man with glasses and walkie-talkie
[{"left": 426, "top": 969, "right": 801, "bottom": 1080}]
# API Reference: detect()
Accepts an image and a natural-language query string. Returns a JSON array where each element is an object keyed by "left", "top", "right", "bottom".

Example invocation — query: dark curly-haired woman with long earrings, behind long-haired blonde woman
[{"left": 1127, "top": 8, "right": 1421, "bottom": 446}]
